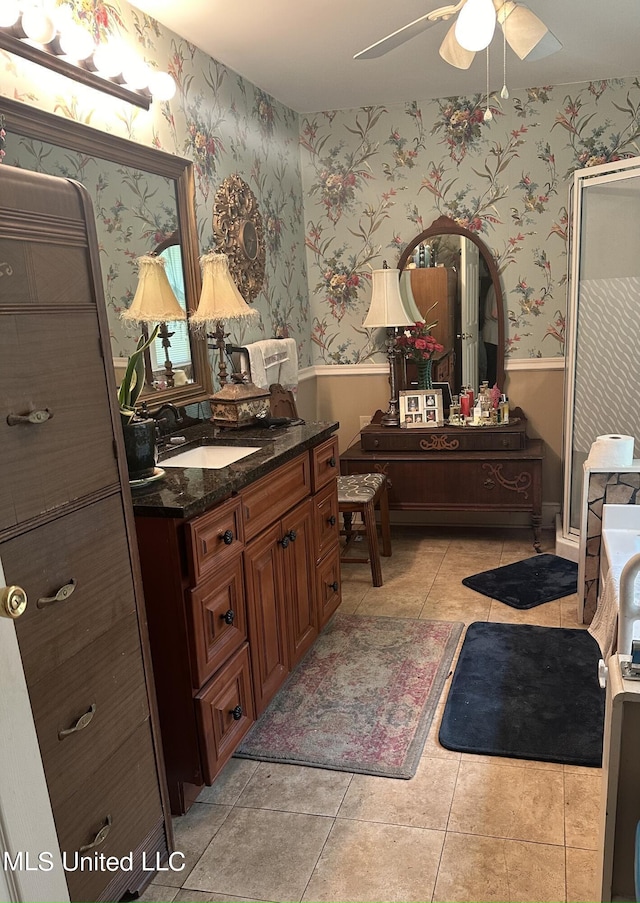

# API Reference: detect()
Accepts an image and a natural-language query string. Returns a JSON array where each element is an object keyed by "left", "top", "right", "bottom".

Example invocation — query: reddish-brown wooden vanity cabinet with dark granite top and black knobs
[{"left": 134, "top": 424, "right": 340, "bottom": 814}]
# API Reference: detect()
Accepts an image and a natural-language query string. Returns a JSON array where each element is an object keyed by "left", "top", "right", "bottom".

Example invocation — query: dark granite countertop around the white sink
[{"left": 131, "top": 421, "right": 339, "bottom": 518}]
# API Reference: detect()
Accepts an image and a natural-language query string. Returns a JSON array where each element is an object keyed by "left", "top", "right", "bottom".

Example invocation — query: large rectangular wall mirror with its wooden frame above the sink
[{"left": 0, "top": 98, "right": 212, "bottom": 409}]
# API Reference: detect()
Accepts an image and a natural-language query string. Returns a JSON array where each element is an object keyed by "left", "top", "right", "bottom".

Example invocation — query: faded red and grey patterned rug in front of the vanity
[{"left": 235, "top": 613, "right": 463, "bottom": 778}]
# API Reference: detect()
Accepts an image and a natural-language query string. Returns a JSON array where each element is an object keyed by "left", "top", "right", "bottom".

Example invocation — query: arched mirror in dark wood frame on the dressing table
[{"left": 398, "top": 216, "right": 504, "bottom": 394}]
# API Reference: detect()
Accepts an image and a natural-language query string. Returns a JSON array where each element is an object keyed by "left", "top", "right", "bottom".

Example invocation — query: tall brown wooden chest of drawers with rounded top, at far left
[{"left": 0, "top": 166, "right": 172, "bottom": 901}]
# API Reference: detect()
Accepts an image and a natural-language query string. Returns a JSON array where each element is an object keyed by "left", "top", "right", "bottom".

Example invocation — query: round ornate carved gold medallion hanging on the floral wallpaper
[{"left": 213, "top": 174, "right": 266, "bottom": 304}]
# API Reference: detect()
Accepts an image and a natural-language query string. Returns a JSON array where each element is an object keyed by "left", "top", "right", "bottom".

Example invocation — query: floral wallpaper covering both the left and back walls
[{"left": 0, "top": 0, "right": 640, "bottom": 376}]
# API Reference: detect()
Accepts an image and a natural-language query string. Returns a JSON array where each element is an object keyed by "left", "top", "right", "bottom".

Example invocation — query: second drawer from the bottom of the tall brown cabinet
[{"left": 29, "top": 614, "right": 149, "bottom": 809}]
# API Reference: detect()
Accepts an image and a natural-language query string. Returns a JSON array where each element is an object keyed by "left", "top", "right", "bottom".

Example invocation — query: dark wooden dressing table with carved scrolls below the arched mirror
[{"left": 340, "top": 408, "right": 544, "bottom": 551}]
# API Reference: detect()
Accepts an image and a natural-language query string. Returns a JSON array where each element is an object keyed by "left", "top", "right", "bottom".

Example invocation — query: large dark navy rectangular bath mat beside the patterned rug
[{"left": 440, "top": 621, "right": 604, "bottom": 767}]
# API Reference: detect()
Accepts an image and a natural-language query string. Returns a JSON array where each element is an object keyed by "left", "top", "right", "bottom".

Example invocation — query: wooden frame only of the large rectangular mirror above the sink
[{"left": 0, "top": 97, "right": 213, "bottom": 408}]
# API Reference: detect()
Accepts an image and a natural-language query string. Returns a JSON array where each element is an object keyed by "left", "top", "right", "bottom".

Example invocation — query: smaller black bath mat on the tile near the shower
[{"left": 462, "top": 555, "right": 578, "bottom": 609}]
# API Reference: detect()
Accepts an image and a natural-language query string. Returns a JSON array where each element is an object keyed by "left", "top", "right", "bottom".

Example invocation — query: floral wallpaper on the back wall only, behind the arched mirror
[{"left": 300, "top": 78, "right": 640, "bottom": 364}]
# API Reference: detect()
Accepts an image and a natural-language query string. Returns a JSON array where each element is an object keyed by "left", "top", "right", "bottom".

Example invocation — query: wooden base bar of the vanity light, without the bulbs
[{"left": 0, "top": 22, "right": 171, "bottom": 110}]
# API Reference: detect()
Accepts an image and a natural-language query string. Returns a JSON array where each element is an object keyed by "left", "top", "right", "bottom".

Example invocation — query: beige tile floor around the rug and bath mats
[{"left": 141, "top": 528, "right": 601, "bottom": 903}]
